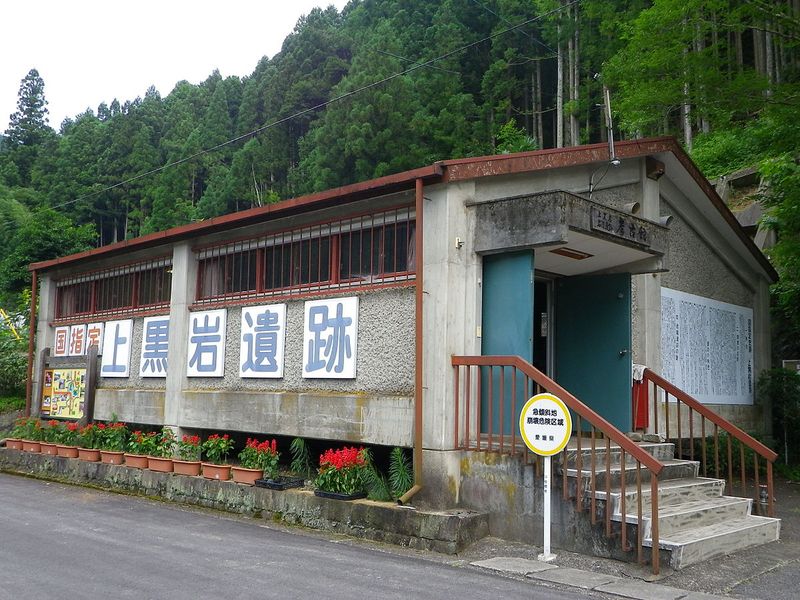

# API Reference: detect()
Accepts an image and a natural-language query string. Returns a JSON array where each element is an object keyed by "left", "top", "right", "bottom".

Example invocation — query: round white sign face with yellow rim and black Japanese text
[{"left": 519, "top": 394, "right": 572, "bottom": 456}]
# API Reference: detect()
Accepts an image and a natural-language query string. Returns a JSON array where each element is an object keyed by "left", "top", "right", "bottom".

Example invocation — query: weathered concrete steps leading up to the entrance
[{"left": 566, "top": 443, "right": 780, "bottom": 569}]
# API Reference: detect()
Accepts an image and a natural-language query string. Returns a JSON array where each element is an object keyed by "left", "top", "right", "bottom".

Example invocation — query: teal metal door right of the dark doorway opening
[{"left": 555, "top": 273, "right": 631, "bottom": 431}]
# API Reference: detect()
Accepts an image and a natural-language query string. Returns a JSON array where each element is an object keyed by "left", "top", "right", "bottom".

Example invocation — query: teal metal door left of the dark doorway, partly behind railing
[{"left": 481, "top": 251, "right": 533, "bottom": 434}]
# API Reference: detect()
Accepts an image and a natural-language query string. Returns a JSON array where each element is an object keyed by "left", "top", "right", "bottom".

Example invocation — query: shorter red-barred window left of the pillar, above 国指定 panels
[{"left": 56, "top": 259, "right": 172, "bottom": 320}]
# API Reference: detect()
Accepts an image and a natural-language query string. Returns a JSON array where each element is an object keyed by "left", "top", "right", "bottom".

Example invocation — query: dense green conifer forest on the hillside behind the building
[{"left": 0, "top": 0, "right": 800, "bottom": 360}]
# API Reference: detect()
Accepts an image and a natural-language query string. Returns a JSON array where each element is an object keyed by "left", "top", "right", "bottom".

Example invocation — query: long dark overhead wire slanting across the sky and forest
[{"left": 17, "top": 0, "right": 581, "bottom": 218}]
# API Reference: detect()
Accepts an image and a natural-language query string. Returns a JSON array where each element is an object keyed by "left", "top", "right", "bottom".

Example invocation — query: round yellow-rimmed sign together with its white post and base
[{"left": 519, "top": 394, "right": 572, "bottom": 562}]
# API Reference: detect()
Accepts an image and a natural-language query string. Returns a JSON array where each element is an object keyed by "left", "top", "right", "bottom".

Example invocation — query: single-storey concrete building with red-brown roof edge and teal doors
[{"left": 30, "top": 138, "right": 777, "bottom": 568}]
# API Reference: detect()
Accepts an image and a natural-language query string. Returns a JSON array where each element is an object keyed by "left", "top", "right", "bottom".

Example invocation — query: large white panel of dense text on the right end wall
[{"left": 661, "top": 288, "right": 753, "bottom": 404}]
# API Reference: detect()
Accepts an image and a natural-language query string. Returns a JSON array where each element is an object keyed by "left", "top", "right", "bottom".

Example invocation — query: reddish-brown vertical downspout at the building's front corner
[{"left": 397, "top": 179, "right": 423, "bottom": 506}]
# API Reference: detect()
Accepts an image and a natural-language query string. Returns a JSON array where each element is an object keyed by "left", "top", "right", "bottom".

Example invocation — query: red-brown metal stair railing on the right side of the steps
[{"left": 644, "top": 369, "right": 778, "bottom": 517}]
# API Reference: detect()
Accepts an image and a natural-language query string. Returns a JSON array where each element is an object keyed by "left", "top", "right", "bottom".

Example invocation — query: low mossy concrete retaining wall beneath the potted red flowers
[{"left": 0, "top": 448, "right": 489, "bottom": 554}]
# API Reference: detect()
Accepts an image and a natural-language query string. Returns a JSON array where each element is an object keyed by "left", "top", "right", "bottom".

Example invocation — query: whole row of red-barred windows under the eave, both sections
[{"left": 56, "top": 208, "right": 416, "bottom": 319}]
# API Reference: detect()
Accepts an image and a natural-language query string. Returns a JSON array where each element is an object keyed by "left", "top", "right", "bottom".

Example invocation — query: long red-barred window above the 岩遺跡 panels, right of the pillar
[{"left": 197, "top": 207, "right": 416, "bottom": 304}]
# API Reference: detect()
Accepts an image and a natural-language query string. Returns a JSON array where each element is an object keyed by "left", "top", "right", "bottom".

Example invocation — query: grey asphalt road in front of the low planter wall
[{"left": 0, "top": 473, "right": 602, "bottom": 600}]
